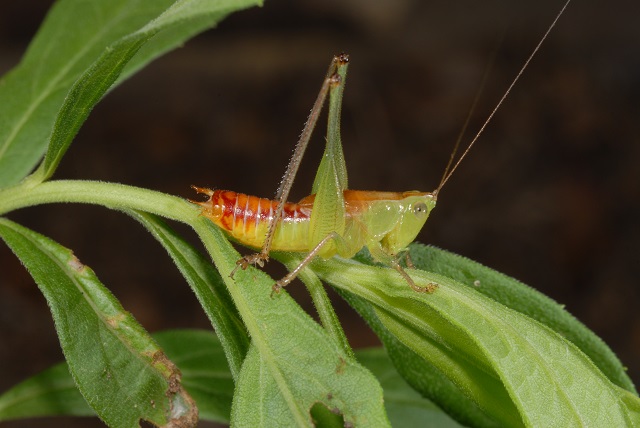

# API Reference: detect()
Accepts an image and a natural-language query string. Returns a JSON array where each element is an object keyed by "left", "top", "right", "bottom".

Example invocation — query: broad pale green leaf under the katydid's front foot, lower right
[{"left": 313, "top": 259, "right": 640, "bottom": 426}]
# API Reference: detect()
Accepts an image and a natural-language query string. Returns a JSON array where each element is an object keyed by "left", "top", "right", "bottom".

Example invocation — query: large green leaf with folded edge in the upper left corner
[{"left": 0, "top": 0, "right": 259, "bottom": 187}]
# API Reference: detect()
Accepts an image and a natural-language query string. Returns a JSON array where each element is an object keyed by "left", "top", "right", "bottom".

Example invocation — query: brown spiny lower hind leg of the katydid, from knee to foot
[{"left": 230, "top": 53, "right": 349, "bottom": 278}]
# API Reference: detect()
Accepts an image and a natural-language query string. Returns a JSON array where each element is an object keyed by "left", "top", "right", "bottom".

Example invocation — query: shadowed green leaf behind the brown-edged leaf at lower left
[{"left": 0, "top": 330, "right": 233, "bottom": 423}]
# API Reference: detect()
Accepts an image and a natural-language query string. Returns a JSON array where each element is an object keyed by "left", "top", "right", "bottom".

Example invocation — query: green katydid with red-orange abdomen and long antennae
[{"left": 192, "top": 0, "right": 570, "bottom": 292}]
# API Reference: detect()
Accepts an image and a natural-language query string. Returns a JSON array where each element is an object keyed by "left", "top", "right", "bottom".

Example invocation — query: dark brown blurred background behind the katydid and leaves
[{"left": 0, "top": 0, "right": 640, "bottom": 426}]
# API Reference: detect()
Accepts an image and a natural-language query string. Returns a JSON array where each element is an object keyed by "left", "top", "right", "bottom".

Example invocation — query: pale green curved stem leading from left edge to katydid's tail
[{"left": 0, "top": 180, "right": 200, "bottom": 224}]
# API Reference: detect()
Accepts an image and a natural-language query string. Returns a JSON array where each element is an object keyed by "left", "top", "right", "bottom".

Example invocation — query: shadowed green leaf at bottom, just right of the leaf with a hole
[{"left": 356, "top": 348, "right": 461, "bottom": 428}]
